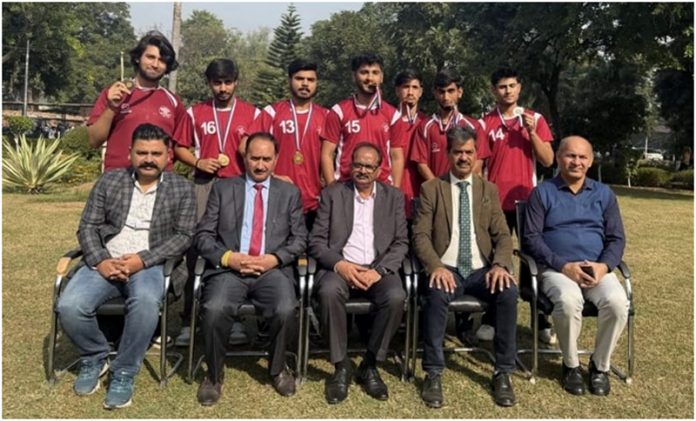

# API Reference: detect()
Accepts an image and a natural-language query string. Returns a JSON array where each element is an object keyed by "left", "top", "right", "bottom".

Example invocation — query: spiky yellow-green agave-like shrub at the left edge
[{"left": 2, "top": 135, "right": 78, "bottom": 193}]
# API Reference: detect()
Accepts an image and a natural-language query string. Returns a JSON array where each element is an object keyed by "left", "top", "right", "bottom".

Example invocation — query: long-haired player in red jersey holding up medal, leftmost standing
[{"left": 87, "top": 31, "right": 186, "bottom": 171}]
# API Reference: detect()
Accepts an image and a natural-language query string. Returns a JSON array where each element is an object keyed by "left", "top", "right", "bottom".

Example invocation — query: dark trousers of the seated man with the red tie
[{"left": 198, "top": 269, "right": 297, "bottom": 382}]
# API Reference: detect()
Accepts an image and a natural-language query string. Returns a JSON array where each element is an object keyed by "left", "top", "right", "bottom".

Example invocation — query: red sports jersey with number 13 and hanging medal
[{"left": 252, "top": 100, "right": 329, "bottom": 212}]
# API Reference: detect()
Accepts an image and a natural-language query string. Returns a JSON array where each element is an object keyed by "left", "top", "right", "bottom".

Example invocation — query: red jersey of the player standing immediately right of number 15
[{"left": 394, "top": 111, "right": 428, "bottom": 219}]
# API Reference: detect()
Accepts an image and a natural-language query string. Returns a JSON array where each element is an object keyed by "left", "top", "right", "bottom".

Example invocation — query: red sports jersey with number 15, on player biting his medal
[{"left": 322, "top": 98, "right": 401, "bottom": 183}]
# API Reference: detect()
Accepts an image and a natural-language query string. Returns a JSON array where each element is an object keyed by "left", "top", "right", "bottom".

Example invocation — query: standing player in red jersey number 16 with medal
[{"left": 174, "top": 59, "right": 261, "bottom": 346}]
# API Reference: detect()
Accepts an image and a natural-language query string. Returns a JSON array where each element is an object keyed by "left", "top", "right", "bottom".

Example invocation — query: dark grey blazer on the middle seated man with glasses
[{"left": 309, "top": 182, "right": 408, "bottom": 273}]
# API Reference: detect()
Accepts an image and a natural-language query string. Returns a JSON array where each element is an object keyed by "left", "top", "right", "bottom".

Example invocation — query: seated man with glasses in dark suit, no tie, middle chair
[{"left": 309, "top": 143, "right": 408, "bottom": 404}]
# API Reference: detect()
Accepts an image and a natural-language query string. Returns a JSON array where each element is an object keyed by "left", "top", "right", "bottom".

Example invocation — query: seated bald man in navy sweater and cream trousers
[{"left": 524, "top": 136, "right": 628, "bottom": 395}]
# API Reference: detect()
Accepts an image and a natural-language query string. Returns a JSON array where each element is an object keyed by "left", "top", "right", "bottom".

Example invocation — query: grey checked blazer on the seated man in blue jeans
[{"left": 77, "top": 168, "right": 196, "bottom": 267}]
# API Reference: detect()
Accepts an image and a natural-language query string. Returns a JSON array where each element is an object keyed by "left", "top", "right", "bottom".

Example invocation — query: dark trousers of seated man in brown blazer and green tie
[{"left": 421, "top": 268, "right": 518, "bottom": 374}]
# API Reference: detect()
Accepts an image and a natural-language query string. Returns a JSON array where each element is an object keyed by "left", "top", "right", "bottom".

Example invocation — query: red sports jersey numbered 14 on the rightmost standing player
[{"left": 481, "top": 108, "right": 553, "bottom": 211}]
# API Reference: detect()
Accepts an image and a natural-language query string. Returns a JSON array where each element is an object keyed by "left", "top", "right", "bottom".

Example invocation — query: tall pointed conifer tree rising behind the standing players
[{"left": 252, "top": 4, "right": 302, "bottom": 105}]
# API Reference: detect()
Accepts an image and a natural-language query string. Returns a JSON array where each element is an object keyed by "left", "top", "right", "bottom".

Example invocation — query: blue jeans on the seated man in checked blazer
[{"left": 57, "top": 265, "right": 164, "bottom": 376}]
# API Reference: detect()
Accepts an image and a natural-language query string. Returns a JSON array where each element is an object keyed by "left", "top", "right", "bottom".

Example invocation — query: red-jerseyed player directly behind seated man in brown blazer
[{"left": 410, "top": 68, "right": 489, "bottom": 181}]
